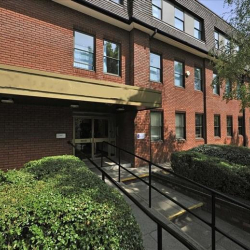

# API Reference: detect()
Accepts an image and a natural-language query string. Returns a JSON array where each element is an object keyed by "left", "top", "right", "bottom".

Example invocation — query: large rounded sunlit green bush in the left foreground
[{"left": 0, "top": 156, "right": 143, "bottom": 249}]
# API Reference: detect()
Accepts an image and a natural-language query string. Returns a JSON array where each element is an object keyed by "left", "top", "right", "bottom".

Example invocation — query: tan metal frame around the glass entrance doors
[{"left": 72, "top": 113, "right": 116, "bottom": 160}]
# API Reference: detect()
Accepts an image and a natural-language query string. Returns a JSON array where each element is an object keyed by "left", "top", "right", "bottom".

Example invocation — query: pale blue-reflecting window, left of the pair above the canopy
[{"left": 74, "top": 31, "right": 95, "bottom": 70}]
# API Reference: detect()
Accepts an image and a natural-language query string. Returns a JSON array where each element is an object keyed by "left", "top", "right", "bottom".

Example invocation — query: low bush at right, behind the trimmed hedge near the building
[{"left": 192, "top": 144, "right": 250, "bottom": 167}]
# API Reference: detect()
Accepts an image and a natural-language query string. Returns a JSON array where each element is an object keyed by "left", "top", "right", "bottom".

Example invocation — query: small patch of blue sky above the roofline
[{"left": 199, "top": 0, "right": 234, "bottom": 21}]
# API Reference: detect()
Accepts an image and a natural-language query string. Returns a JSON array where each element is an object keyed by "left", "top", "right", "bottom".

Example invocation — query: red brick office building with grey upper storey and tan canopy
[{"left": 0, "top": 0, "right": 250, "bottom": 170}]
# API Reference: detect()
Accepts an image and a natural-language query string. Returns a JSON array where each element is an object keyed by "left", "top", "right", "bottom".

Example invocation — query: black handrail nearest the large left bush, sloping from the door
[{"left": 68, "top": 141, "right": 198, "bottom": 250}]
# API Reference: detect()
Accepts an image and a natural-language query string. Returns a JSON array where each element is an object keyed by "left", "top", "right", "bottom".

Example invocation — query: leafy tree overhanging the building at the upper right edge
[{"left": 210, "top": 0, "right": 250, "bottom": 109}]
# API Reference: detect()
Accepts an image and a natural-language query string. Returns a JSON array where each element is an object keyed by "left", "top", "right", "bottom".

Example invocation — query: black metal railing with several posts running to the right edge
[{"left": 101, "top": 141, "right": 250, "bottom": 250}]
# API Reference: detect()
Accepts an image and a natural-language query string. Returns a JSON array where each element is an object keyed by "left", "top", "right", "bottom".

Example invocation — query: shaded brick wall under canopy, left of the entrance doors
[{"left": 0, "top": 104, "right": 73, "bottom": 170}]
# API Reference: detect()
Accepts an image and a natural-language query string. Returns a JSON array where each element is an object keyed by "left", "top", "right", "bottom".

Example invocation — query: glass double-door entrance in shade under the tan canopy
[{"left": 74, "top": 116, "right": 116, "bottom": 159}]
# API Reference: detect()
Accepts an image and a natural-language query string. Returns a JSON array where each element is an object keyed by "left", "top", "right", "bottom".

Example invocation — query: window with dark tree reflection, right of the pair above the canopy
[{"left": 103, "top": 41, "right": 120, "bottom": 75}]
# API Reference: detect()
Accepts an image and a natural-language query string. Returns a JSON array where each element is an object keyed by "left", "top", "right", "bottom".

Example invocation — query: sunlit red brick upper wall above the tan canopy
[{"left": 0, "top": 0, "right": 129, "bottom": 84}]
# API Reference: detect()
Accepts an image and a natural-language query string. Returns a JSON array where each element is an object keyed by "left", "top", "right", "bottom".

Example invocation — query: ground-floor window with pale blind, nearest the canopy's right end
[{"left": 150, "top": 112, "right": 163, "bottom": 141}]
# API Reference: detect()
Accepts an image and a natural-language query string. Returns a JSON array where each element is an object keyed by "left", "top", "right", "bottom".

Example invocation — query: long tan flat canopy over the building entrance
[{"left": 0, "top": 64, "right": 161, "bottom": 108}]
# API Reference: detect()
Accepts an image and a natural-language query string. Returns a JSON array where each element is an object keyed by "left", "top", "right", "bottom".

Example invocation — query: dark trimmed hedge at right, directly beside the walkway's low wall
[{"left": 171, "top": 150, "right": 250, "bottom": 200}]
